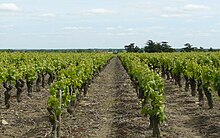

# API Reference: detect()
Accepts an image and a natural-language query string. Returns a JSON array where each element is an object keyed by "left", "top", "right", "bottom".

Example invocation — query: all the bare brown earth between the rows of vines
[{"left": 0, "top": 58, "right": 220, "bottom": 138}]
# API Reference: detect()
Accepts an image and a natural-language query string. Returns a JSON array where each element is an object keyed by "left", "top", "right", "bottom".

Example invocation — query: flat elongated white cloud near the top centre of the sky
[{"left": 86, "top": 8, "right": 117, "bottom": 15}]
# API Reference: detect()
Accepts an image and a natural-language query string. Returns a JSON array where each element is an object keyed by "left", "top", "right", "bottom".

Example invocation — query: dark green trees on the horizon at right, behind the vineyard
[{"left": 124, "top": 40, "right": 219, "bottom": 53}]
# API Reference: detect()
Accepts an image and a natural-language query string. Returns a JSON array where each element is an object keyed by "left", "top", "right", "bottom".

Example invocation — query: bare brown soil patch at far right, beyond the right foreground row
[{"left": 161, "top": 80, "right": 220, "bottom": 138}]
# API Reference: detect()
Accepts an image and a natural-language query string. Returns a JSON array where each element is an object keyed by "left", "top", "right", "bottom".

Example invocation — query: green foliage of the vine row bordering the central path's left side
[{"left": 45, "top": 54, "right": 112, "bottom": 127}]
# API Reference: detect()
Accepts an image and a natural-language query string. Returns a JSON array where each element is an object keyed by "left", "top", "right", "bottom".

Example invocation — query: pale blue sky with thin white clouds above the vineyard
[{"left": 0, "top": 0, "right": 220, "bottom": 49}]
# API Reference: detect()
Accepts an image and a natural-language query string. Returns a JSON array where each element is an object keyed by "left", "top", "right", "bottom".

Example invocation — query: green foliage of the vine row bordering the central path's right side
[{"left": 120, "top": 54, "right": 166, "bottom": 123}]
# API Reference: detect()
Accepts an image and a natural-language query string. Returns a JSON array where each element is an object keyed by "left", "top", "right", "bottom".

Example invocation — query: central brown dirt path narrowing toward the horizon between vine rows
[{"left": 65, "top": 58, "right": 151, "bottom": 138}]
